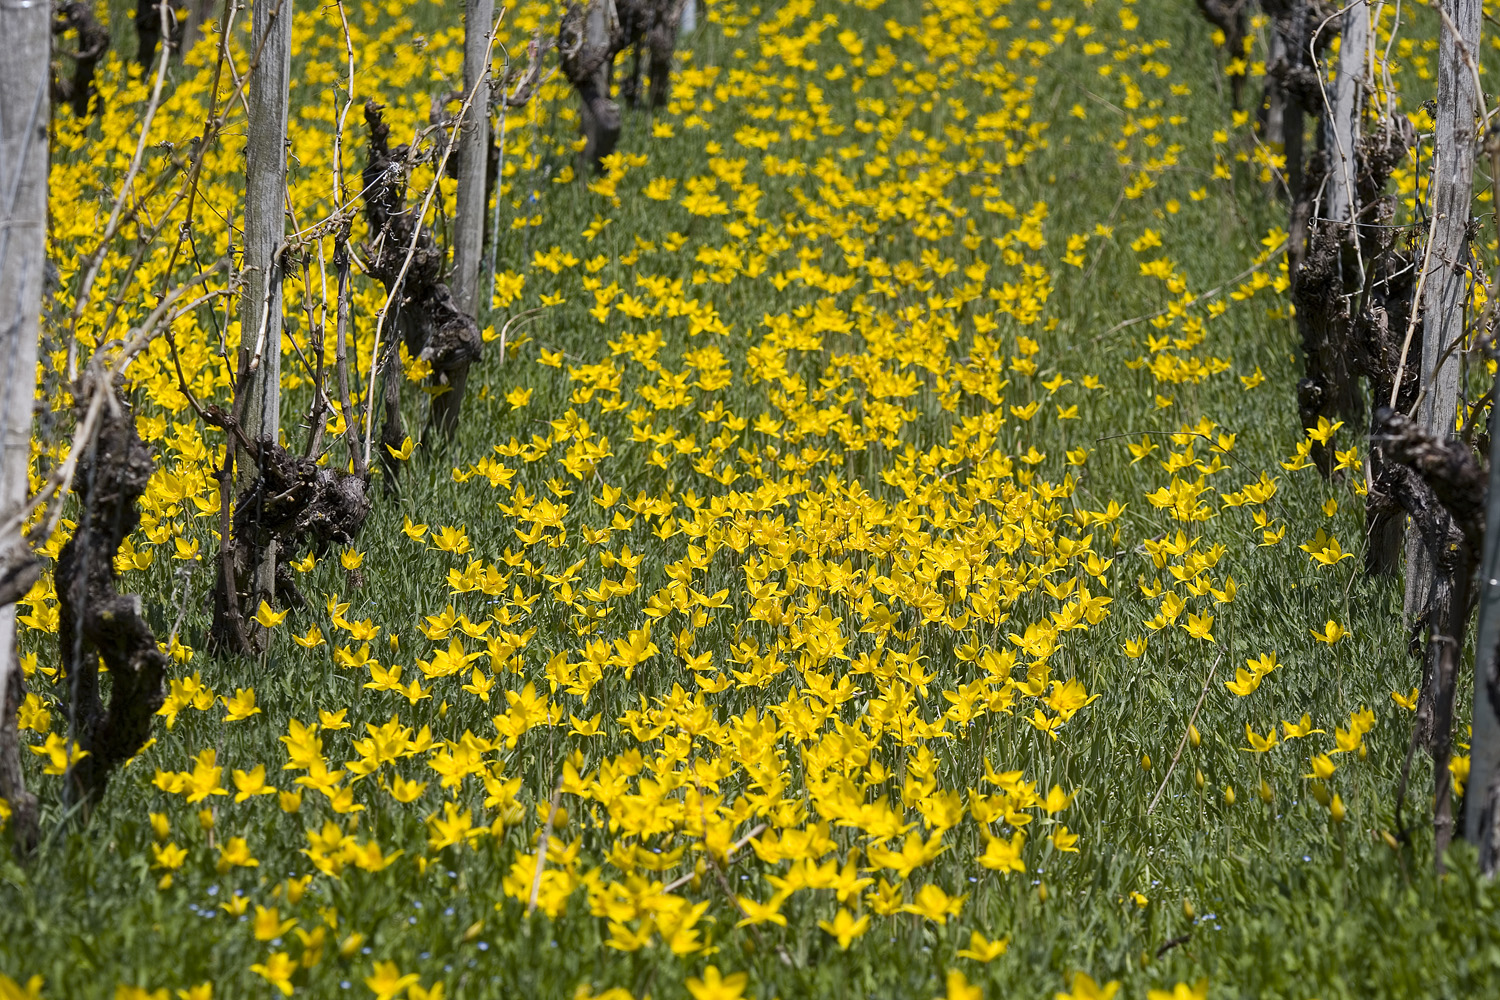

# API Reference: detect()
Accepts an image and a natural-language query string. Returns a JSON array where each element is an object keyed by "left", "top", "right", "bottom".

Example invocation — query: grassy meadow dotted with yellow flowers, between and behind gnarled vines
[{"left": 0, "top": 0, "right": 1500, "bottom": 1000}]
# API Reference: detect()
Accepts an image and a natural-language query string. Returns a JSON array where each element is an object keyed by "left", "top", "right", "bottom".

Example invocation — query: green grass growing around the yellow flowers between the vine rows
[{"left": 0, "top": 0, "right": 1500, "bottom": 1000}]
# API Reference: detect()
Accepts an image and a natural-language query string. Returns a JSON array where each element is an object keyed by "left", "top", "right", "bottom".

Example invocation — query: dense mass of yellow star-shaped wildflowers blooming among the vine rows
[{"left": 0, "top": 0, "right": 1467, "bottom": 1000}]
